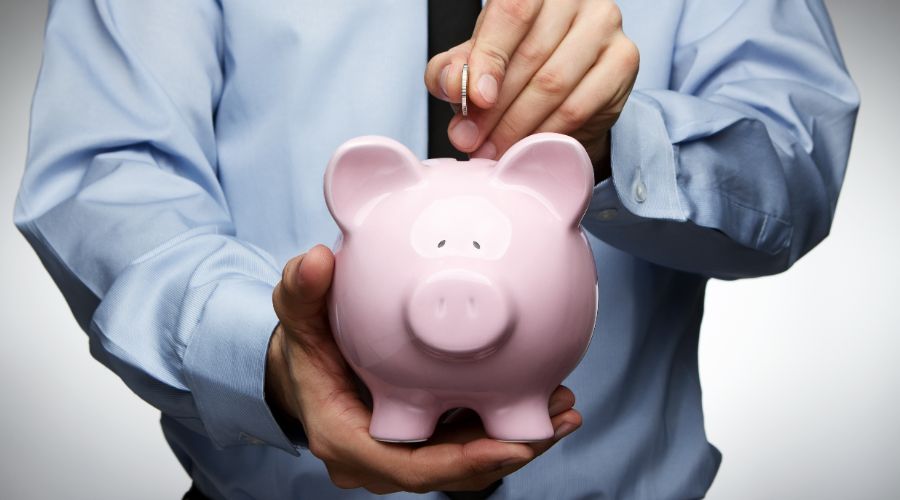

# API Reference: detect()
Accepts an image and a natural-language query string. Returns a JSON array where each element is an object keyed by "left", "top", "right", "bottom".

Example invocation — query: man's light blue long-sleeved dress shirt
[{"left": 15, "top": 0, "right": 859, "bottom": 499}]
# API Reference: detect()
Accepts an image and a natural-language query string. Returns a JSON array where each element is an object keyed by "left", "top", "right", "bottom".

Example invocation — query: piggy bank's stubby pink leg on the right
[{"left": 478, "top": 395, "right": 553, "bottom": 442}]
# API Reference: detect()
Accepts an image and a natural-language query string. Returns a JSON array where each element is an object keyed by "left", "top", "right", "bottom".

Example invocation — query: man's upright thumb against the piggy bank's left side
[{"left": 273, "top": 245, "right": 334, "bottom": 327}]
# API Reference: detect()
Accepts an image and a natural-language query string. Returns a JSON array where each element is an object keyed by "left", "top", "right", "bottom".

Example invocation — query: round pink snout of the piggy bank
[{"left": 406, "top": 271, "right": 512, "bottom": 359}]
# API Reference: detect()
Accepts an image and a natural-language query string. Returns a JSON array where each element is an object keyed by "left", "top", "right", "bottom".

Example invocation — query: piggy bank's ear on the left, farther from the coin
[{"left": 325, "top": 136, "right": 422, "bottom": 232}]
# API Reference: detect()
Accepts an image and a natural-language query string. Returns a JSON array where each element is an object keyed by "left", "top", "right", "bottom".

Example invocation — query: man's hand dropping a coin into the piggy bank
[{"left": 425, "top": 0, "right": 639, "bottom": 181}]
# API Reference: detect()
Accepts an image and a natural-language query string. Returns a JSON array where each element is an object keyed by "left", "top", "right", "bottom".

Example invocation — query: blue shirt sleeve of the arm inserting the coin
[{"left": 583, "top": 0, "right": 859, "bottom": 279}]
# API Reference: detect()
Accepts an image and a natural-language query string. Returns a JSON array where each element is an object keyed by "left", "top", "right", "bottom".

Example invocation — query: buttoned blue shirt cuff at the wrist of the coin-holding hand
[{"left": 586, "top": 92, "right": 687, "bottom": 227}]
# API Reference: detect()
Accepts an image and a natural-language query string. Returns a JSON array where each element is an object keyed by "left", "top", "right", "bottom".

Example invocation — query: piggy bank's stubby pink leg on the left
[{"left": 369, "top": 395, "right": 440, "bottom": 443}]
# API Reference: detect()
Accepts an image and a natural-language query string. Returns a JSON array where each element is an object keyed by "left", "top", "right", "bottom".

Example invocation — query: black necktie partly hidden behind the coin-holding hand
[{"left": 428, "top": 0, "right": 481, "bottom": 160}]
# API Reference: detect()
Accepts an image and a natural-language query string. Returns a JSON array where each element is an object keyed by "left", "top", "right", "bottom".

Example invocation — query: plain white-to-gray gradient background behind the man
[{"left": 0, "top": 0, "right": 900, "bottom": 500}]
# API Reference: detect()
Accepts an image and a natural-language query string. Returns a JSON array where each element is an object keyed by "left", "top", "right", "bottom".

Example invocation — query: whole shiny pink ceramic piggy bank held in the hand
[{"left": 325, "top": 133, "right": 597, "bottom": 442}]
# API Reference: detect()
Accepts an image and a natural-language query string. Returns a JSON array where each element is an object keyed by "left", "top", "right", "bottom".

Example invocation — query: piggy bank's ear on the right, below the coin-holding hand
[{"left": 494, "top": 132, "right": 594, "bottom": 225}]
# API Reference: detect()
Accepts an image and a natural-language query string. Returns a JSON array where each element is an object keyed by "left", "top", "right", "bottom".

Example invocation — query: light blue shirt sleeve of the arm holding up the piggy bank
[{"left": 15, "top": 0, "right": 298, "bottom": 454}]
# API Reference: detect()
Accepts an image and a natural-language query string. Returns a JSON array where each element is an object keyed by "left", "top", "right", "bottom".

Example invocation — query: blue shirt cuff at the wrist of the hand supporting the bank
[{"left": 184, "top": 279, "right": 300, "bottom": 456}]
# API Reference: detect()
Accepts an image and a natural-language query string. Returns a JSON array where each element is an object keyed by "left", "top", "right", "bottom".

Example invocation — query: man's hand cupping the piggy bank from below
[{"left": 266, "top": 245, "right": 581, "bottom": 494}]
